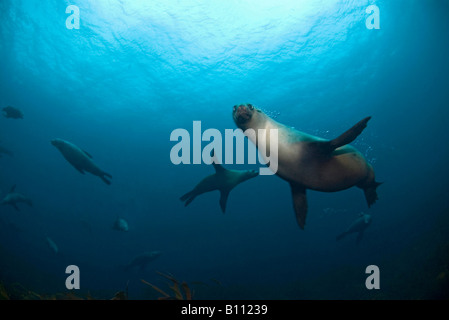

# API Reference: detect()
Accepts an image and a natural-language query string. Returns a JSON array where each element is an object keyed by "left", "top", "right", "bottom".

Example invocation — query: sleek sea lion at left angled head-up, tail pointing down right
[{"left": 51, "top": 139, "right": 112, "bottom": 185}]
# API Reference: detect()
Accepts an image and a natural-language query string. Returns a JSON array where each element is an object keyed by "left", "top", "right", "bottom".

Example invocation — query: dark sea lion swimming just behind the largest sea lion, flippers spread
[{"left": 180, "top": 158, "right": 259, "bottom": 213}]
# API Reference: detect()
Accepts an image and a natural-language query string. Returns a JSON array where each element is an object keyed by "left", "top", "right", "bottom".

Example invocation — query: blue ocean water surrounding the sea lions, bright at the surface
[{"left": 0, "top": 0, "right": 449, "bottom": 299}]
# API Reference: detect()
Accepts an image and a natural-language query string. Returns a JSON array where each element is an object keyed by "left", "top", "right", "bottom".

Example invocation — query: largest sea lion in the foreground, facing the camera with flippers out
[{"left": 233, "top": 104, "right": 380, "bottom": 229}]
